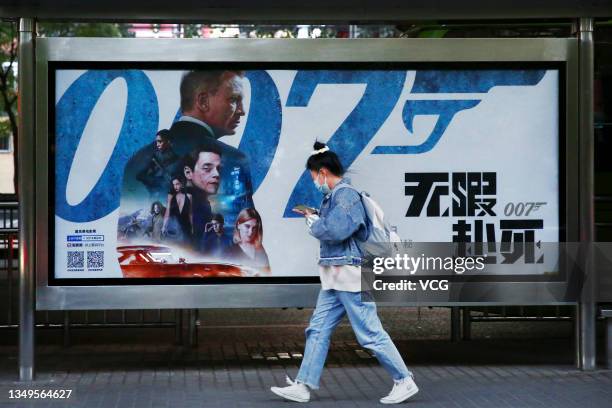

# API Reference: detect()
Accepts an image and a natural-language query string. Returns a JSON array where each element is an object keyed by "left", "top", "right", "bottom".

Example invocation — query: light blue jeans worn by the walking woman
[{"left": 295, "top": 289, "right": 412, "bottom": 389}]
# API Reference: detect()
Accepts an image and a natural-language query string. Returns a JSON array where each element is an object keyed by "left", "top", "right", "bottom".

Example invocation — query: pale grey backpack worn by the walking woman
[{"left": 336, "top": 183, "right": 402, "bottom": 258}]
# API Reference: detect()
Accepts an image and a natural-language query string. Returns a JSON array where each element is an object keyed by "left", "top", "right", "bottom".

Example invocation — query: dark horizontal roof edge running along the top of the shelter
[{"left": 0, "top": 0, "right": 611, "bottom": 20}]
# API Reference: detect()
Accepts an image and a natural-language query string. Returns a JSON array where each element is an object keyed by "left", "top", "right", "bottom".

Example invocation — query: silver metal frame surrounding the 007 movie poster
[{"left": 35, "top": 38, "right": 580, "bottom": 310}]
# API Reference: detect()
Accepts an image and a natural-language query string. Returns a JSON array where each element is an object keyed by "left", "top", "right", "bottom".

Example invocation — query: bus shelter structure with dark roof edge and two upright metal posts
[{"left": 0, "top": 0, "right": 612, "bottom": 381}]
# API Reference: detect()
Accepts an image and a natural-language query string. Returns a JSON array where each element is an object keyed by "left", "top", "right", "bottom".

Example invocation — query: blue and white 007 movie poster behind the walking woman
[{"left": 50, "top": 64, "right": 560, "bottom": 279}]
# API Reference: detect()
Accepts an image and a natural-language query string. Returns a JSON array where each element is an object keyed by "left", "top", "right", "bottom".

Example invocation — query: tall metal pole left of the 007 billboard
[{"left": 18, "top": 18, "right": 35, "bottom": 381}]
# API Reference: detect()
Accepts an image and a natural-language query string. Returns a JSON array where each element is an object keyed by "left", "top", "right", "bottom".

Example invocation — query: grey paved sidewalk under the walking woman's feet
[{"left": 0, "top": 340, "right": 612, "bottom": 408}]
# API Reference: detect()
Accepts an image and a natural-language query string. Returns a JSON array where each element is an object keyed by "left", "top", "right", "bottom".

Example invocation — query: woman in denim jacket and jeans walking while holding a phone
[{"left": 271, "top": 142, "right": 419, "bottom": 404}]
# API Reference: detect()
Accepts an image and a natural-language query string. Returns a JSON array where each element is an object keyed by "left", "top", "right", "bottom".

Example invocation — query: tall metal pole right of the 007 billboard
[{"left": 578, "top": 18, "right": 596, "bottom": 370}]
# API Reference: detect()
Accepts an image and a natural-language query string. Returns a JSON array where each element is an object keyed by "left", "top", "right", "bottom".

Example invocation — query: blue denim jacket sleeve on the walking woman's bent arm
[{"left": 310, "top": 188, "right": 365, "bottom": 241}]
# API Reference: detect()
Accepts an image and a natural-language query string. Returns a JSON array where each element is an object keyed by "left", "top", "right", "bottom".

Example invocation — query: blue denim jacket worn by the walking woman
[{"left": 310, "top": 177, "right": 368, "bottom": 265}]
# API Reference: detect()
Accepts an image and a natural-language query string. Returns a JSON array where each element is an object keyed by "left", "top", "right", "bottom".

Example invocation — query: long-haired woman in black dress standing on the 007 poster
[{"left": 162, "top": 177, "right": 193, "bottom": 244}]
